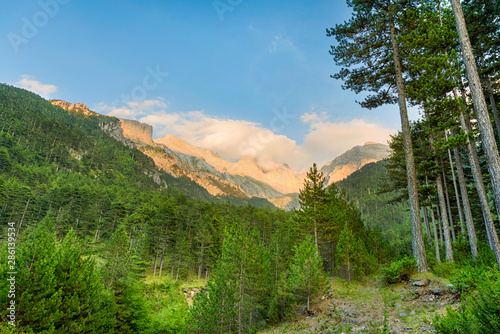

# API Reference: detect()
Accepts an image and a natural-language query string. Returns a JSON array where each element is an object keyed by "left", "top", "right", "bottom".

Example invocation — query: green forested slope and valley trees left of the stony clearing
[{"left": 0, "top": 85, "right": 391, "bottom": 333}]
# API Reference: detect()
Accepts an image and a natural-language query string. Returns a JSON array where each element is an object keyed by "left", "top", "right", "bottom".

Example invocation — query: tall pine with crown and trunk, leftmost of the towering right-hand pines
[{"left": 327, "top": 0, "right": 429, "bottom": 272}]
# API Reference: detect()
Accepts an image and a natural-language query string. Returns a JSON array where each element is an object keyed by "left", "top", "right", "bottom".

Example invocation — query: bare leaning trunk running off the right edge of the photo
[{"left": 451, "top": 0, "right": 500, "bottom": 227}]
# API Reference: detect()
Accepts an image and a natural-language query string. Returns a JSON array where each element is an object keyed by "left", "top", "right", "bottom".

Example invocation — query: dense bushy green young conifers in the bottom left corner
[{"left": 0, "top": 218, "right": 114, "bottom": 333}]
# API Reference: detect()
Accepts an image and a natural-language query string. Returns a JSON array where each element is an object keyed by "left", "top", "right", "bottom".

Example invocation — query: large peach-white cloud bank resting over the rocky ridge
[{"left": 96, "top": 99, "right": 396, "bottom": 170}]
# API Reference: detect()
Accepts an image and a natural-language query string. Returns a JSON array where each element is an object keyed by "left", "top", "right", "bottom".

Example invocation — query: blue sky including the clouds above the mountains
[{"left": 0, "top": 0, "right": 416, "bottom": 168}]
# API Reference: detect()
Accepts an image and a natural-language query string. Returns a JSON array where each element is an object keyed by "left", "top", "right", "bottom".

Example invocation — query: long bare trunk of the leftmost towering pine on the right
[{"left": 387, "top": 0, "right": 429, "bottom": 272}]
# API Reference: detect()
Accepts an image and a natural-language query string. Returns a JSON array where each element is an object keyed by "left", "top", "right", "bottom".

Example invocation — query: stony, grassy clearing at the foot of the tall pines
[{"left": 260, "top": 274, "right": 459, "bottom": 334}]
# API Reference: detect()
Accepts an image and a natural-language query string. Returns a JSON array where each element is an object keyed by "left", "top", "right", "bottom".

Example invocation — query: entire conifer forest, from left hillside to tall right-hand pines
[{"left": 0, "top": 0, "right": 500, "bottom": 334}]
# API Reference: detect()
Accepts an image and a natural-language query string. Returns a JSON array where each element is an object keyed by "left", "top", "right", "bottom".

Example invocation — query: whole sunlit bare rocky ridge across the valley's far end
[{"left": 47, "top": 100, "right": 389, "bottom": 210}]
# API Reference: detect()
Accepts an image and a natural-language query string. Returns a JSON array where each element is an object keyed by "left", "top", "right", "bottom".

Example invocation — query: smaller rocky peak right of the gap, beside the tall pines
[{"left": 321, "top": 142, "right": 389, "bottom": 185}]
